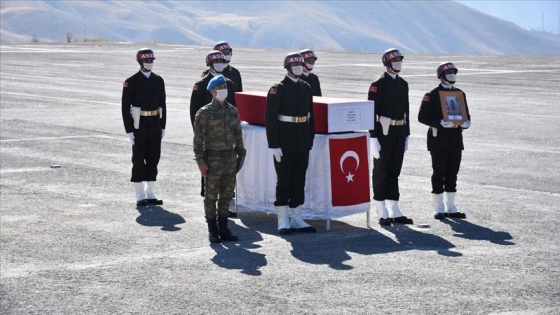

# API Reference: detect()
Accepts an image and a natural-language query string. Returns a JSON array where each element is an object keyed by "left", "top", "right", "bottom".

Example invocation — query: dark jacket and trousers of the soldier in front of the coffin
[{"left": 265, "top": 76, "right": 315, "bottom": 208}]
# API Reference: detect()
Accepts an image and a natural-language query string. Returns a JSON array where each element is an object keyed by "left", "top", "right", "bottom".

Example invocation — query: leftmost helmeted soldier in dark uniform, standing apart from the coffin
[{"left": 122, "top": 48, "right": 167, "bottom": 206}]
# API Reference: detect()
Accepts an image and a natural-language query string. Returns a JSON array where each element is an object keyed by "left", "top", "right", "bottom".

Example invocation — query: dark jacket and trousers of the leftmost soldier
[{"left": 121, "top": 71, "right": 167, "bottom": 182}]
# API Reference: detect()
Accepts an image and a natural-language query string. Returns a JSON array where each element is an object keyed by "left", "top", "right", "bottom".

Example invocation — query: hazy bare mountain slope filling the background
[{"left": 0, "top": 0, "right": 560, "bottom": 55}]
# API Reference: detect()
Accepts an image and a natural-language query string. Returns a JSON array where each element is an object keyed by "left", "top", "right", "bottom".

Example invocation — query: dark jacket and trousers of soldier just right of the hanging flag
[{"left": 368, "top": 72, "right": 410, "bottom": 201}]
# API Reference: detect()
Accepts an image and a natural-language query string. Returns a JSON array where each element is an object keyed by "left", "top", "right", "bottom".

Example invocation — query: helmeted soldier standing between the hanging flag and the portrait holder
[{"left": 368, "top": 48, "right": 413, "bottom": 225}]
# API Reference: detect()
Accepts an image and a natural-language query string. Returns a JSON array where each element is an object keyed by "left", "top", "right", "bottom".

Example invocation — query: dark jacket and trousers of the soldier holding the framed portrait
[{"left": 418, "top": 84, "right": 471, "bottom": 194}]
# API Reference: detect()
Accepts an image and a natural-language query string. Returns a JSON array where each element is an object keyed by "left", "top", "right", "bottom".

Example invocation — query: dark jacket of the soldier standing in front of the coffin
[{"left": 265, "top": 76, "right": 315, "bottom": 153}]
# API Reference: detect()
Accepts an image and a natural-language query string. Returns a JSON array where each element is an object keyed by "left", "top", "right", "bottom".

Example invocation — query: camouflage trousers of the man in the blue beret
[{"left": 204, "top": 155, "right": 237, "bottom": 219}]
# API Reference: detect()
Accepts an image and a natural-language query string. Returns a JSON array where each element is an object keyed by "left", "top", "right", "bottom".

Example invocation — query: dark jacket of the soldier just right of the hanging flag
[{"left": 368, "top": 72, "right": 410, "bottom": 142}]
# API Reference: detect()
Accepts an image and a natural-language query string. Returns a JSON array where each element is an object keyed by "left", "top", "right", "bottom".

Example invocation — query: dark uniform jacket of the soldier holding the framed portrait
[{"left": 418, "top": 84, "right": 471, "bottom": 151}]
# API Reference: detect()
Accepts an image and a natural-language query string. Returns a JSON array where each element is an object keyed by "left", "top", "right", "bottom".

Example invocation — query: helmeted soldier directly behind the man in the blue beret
[{"left": 190, "top": 50, "right": 236, "bottom": 217}]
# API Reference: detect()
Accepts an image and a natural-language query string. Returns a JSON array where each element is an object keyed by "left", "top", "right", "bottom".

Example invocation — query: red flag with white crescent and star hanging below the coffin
[{"left": 329, "top": 135, "right": 370, "bottom": 206}]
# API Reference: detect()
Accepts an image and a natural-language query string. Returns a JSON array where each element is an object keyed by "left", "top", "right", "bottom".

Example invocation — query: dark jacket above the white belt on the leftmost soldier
[{"left": 121, "top": 71, "right": 167, "bottom": 133}]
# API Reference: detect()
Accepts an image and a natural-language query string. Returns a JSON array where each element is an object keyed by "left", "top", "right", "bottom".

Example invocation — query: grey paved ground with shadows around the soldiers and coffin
[{"left": 0, "top": 44, "right": 560, "bottom": 314}]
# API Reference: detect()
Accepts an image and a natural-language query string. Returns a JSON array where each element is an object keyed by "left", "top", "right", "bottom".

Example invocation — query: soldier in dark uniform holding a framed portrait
[{"left": 418, "top": 62, "right": 471, "bottom": 220}]
